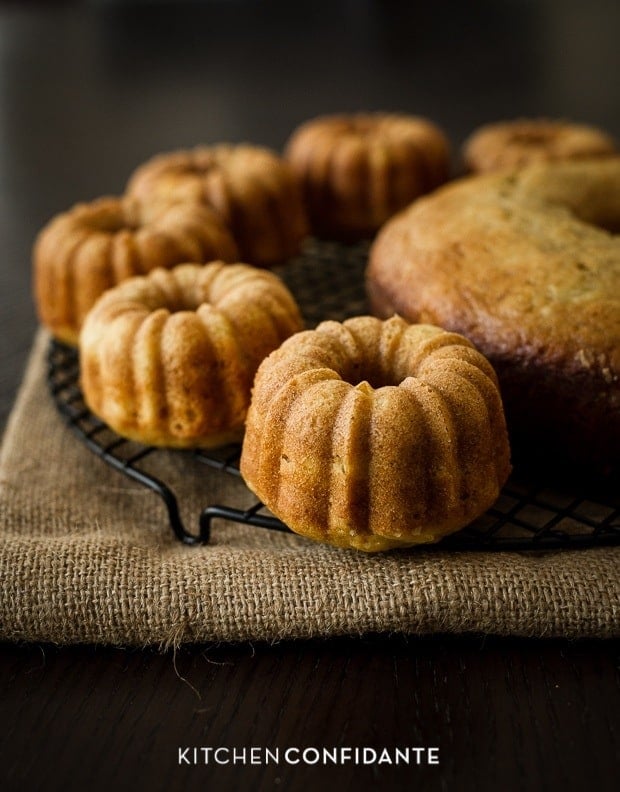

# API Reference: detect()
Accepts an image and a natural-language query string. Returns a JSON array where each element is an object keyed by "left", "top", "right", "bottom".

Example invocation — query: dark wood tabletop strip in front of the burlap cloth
[{"left": 0, "top": 637, "right": 620, "bottom": 792}]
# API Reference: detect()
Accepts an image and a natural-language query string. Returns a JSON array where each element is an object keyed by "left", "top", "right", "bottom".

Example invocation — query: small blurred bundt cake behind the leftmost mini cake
[{"left": 127, "top": 144, "right": 308, "bottom": 267}]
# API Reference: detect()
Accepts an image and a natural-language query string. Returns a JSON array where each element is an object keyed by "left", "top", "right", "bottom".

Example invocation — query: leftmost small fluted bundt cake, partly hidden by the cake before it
[{"left": 33, "top": 198, "right": 238, "bottom": 345}]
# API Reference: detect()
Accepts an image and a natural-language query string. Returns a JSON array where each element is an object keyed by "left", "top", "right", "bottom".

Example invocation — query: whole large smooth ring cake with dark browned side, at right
[{"left": 366, "top": 158, "right": 620, "bottom": 471}]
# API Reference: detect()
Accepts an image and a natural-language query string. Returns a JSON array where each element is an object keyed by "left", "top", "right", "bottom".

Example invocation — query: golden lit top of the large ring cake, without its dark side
[{"left": 368, "top": 159, "right": 620, "bottom": 381}]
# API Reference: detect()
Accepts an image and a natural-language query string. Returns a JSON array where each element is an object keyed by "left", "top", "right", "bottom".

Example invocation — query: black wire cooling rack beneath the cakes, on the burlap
[{"left": 48, "top": 241, "right": 620, "bottom": 551}]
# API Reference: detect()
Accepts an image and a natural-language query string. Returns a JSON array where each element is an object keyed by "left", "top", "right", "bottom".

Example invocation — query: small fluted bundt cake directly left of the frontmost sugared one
[{"left": 80, "top": 261, "right": 302, "bottom": 448}]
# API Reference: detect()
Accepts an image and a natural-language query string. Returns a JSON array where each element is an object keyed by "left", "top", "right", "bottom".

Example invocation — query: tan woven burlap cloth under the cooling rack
[{"left": 0, "top": 332, "right": 620, "bottom": 646}]
